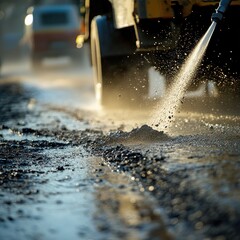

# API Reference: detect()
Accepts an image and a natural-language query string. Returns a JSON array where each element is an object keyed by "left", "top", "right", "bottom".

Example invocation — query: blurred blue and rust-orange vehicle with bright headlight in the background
[{"left": 25, "top": 4, "right": 80, "bottom": 68}]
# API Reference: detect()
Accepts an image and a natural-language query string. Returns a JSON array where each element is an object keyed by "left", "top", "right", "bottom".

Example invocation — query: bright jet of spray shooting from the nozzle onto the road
[{"left": 151, "top": 22, "right": 216, "bottom": 130}]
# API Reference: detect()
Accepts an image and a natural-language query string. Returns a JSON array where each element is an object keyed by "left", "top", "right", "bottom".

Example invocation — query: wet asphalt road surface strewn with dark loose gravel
[{"left": 0, "top": 46, "right": 240, "bottom": 240}]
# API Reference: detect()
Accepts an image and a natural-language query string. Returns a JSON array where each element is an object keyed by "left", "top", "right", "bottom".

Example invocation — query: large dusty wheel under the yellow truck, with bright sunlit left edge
[{"left": 91, "top": 16, "right": 148, "bottom": 107}]
